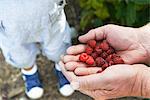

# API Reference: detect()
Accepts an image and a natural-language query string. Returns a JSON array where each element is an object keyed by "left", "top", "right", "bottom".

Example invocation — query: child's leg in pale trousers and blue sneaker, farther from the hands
[{"left": 0, "top": 39, "right": 43, "bottom": 98}]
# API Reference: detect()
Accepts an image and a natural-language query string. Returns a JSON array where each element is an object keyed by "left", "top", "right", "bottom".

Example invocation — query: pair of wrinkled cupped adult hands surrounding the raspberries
[{"left": 60, "top": 25, "right": 149, "bottom": 100}]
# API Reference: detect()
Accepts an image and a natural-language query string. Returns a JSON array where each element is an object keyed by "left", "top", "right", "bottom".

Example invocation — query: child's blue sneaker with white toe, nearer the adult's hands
[{"left": 54, "top": 63, "right": 74, "bottom": 97}]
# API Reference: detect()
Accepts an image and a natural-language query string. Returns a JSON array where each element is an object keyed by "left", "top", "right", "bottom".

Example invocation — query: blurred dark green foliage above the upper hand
[{"left": 66, "top": 0, "right": 150, "bottom": 31}]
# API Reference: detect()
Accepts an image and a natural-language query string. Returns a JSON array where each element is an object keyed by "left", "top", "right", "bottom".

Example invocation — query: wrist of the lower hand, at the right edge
[{"left": 134, "top": 64, "right": 150, "bottom": 98}]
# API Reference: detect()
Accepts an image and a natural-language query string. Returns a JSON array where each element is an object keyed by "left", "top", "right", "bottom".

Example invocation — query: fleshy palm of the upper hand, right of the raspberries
[{"left": 104, "top": 26, "right": 147, "bottom": 64}]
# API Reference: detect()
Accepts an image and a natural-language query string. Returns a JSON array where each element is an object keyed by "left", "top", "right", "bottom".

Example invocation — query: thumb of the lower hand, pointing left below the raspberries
[{"left": 71, "top": 73, "right": 106, "bottom": 90}]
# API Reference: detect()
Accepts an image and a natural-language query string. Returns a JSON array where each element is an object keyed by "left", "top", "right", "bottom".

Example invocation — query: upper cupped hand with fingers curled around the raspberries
[{"left": 63, "top": 25, "right": 149, "bottom": 75}]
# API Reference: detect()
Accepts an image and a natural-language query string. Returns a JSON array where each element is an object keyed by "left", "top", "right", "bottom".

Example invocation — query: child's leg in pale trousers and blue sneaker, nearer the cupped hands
[{"left": 41, "top": 10, "right": 74, "bottom": 96}]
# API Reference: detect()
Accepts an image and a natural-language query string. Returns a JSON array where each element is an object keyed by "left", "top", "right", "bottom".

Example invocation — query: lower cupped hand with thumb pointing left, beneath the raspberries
[{"left": 60, "top": 62, "right": 150, "bottom": 100}]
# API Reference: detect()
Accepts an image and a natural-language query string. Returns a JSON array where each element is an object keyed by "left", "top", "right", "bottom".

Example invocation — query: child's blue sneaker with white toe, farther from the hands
[{"left": 22, "top": 65, "right": 44, "bottom": 99}]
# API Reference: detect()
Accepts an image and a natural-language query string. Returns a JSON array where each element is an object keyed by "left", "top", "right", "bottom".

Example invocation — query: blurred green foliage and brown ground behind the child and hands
[{"left": 0, "top": 0, "right": 150, "bottom": 100}]
